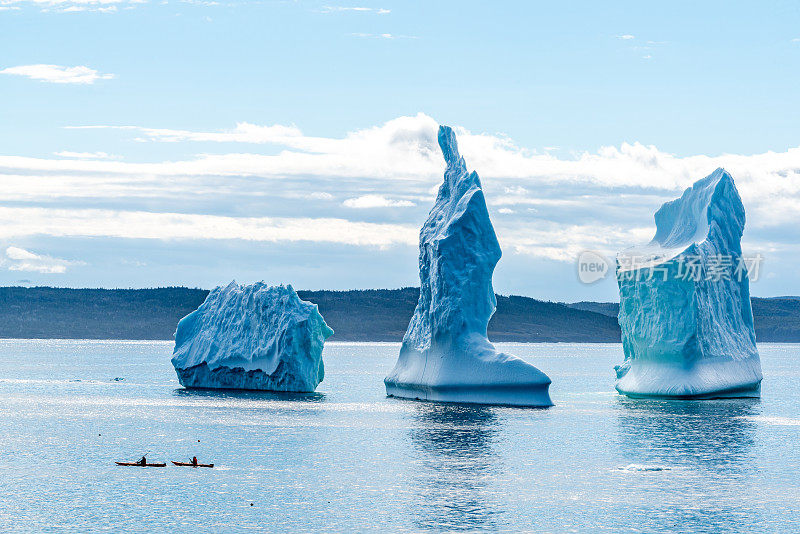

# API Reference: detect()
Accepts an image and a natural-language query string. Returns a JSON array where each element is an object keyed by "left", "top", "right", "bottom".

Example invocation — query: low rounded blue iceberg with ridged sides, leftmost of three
[{"left": 172, "top": 282, "right": 333, "bottom": 392}]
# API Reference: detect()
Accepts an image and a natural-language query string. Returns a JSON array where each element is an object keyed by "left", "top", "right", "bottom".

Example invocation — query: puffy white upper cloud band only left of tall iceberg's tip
[{"left": 59, "top": 113, "right": 441, "bottom": 181}]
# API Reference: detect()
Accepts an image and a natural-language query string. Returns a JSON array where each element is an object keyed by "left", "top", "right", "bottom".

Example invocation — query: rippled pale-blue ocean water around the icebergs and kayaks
[{"left": 0, "top": 340, "right": 800, "bottom": 533}]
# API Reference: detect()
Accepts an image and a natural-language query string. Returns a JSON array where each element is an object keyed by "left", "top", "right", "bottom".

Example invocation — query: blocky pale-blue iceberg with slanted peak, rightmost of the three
[{"left": 616, "top": 169, "right": 762, "bottom": 398}]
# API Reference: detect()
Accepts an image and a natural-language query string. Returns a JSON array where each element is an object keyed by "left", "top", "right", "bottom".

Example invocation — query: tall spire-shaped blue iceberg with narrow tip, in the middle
[{"left": 384, "top": 126, "right": 552, "bottom": 406}]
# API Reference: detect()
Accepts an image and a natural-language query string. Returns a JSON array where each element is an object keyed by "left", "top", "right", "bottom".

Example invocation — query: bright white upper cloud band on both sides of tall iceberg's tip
[{"left": 9, "top": 114, "right": 800, "bottom": 204}]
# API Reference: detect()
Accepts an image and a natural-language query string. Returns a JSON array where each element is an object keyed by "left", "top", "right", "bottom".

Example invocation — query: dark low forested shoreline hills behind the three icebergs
[{"left": 0, "top": 287, "right": 800, "bottom": 343}]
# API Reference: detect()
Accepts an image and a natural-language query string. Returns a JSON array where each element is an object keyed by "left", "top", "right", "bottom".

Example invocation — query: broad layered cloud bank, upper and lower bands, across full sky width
[{"left": 0, "top": 114, "right": 800, "bottom": 261}]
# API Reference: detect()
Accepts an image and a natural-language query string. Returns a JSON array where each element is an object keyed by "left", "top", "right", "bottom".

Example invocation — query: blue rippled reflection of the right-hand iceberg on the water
[{"left": 615, "top": 397, "right": 766, "bottom": 532}]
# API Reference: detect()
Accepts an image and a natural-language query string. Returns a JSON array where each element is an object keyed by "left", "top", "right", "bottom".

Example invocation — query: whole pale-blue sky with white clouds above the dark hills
[{"left": 0, "top": 0, "right": 800, "bottom": 301}]
